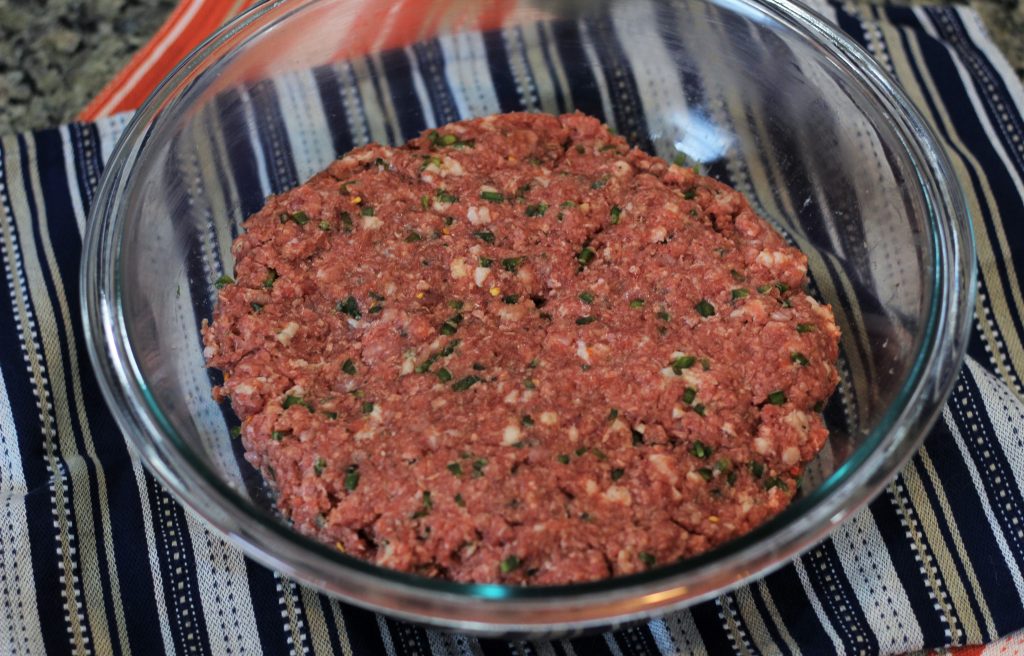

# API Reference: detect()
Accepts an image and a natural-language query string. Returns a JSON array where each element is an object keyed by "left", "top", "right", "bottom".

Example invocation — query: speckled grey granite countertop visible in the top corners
[{"left": 0, "top": 0, "right": 1024, "bottom": 134}]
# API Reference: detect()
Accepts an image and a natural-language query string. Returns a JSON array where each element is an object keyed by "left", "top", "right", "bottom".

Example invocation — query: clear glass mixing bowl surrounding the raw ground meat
[{"left": 81, "top": 0, "right": 976, "bottom": 635}]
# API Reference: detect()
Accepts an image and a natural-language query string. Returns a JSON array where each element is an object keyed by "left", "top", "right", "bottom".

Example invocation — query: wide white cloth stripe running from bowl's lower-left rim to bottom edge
[{"left": 184, "top": 512, "right": 263, "bottom": 655}]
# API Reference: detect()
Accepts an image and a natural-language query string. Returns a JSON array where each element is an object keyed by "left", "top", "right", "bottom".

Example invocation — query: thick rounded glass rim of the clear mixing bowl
[{"left": 79, "top": 0, "right": 977, "bottom": 635}]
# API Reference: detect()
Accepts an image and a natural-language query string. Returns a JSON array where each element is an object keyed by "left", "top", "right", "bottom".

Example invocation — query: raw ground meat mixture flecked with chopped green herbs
[{"left": 203, "top": 114, "right": 839, "bottom": 584}]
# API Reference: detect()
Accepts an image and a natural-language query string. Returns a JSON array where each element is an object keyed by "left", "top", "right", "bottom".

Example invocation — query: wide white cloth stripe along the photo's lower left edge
[{"left": 0, "top": 364, "right": 45, "bottom": 656}]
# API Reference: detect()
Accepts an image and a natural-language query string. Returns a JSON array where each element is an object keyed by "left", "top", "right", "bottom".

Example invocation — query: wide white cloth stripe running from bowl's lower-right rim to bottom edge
[{"left": 831, "top": 501, "right": 925, "bottom": 653}]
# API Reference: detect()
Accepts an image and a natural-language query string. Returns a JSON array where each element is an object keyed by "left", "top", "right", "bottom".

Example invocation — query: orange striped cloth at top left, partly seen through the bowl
[{"left": 78, "top": 0, "right": 516, "bottom": 121}]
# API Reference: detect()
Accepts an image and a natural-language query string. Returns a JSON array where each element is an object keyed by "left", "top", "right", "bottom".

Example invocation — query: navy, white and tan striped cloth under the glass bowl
[{"left": 0, "top": 4, "right": 1024, "bottom": 655}]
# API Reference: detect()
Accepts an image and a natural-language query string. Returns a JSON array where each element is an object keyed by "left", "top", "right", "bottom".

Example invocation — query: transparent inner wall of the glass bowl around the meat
[{"left": 92, "top": 0, "right": 962, "bottom": 630}]
